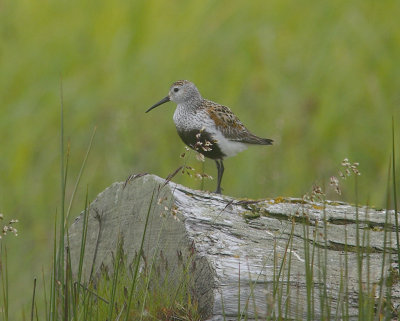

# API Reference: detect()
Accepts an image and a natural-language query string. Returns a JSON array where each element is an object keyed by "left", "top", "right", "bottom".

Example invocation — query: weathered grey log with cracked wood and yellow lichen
[{"left": 69, "top": 175, "right": 400, "bottom": 320}]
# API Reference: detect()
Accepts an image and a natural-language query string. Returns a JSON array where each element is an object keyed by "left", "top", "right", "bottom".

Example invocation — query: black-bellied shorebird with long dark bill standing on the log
[{"left": 146, "top": 80, "right": 273, "bottom": 194}]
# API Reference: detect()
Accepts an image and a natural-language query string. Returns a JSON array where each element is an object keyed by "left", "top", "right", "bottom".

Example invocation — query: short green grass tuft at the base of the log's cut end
[{"left": 39, "top": 222, "right": 200, "bottom": 321}]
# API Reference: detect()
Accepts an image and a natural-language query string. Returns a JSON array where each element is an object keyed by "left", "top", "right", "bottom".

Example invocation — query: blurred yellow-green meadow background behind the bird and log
[{"left": 0, "top": 0, "right": 400, "bottom": 315}]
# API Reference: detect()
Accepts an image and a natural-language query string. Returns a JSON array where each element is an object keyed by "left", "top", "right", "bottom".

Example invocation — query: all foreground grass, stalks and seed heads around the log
[{"left": 0, "top": 118, "right": 400, "bottom": 321}]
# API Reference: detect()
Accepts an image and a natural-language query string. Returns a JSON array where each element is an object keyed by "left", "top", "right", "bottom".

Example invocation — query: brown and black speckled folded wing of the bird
[{"left": 204, "top": 100, "right": 272, "bottom": 145}]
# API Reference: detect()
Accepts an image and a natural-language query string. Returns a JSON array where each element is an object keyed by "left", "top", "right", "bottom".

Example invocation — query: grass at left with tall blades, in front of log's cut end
[{"left": 0, "top": 101, "right": 200, "bottom": 321}]
